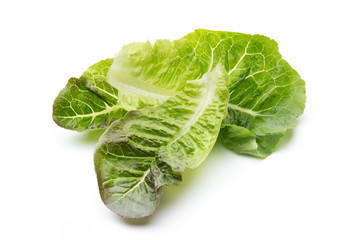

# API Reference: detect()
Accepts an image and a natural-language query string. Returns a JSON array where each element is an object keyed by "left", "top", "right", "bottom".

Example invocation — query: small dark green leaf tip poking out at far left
[{"left": 53, "top": 59, "right": 126, "bottom": 131}]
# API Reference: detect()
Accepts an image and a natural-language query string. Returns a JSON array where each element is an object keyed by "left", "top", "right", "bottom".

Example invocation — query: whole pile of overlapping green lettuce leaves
[{"left": 53, "top": 29, "right": 306, "bottom": 217}]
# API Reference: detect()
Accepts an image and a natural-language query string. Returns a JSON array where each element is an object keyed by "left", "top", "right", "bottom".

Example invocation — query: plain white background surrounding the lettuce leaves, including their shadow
[{"left": 0, "top": 0, "right": 360, "bottom": 240}]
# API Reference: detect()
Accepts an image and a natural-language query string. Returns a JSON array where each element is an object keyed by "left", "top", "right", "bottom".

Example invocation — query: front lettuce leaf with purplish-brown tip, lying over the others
[{"left": 95, "top": 64, "right": 229, "bottom": 218}]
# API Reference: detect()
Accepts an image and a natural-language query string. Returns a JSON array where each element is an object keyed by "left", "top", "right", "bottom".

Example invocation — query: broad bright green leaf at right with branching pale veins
[{"left": 184, "top": 30, "right": 305, "bottom": 157}]
